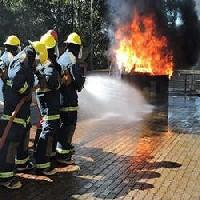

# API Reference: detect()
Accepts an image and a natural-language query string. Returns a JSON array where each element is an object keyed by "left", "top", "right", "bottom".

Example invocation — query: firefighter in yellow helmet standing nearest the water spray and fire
[{"left": 56, "top": 33, "right": 85, "bottom": 164}]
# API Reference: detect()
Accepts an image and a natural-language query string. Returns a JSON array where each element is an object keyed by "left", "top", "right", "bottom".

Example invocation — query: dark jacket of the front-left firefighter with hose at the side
[{"left": 4, "top": 52, "right": 34, "bottom": 120}]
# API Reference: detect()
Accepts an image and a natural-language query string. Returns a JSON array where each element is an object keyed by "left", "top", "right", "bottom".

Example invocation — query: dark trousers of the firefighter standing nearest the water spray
[{"left": 56, "top": 110, "right": 77, "bottom": 160}]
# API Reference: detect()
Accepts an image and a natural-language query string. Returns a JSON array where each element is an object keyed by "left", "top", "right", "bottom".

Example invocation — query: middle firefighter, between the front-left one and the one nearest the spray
[{"left": 35, "top": 34, "right": 60, "bottom": 175}]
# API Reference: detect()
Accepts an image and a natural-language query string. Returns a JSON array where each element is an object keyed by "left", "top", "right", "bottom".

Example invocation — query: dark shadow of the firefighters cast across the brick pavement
[{"left": 0, "top": 145, "right": 181, "bottom": 200}]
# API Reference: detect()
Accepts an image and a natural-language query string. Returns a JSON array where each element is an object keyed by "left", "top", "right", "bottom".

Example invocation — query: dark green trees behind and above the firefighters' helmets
[{"left": 0, "top": 0, "right": 108, "bottom": 68}]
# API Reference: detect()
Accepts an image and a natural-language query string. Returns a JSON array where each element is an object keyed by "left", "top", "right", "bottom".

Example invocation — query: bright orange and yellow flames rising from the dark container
[{"left": 114, "top": 15, "right": 173, "bottom": 76}]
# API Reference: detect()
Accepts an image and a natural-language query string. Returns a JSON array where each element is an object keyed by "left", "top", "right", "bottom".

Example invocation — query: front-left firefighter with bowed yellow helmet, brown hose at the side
[{"left": 0, "top": 41, "right": 47, "bottom": 189}]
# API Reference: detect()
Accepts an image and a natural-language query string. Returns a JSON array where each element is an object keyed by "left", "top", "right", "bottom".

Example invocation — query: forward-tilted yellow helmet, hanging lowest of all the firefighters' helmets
[{"left": 29, "top": 41, "right": 48, "bottom": 64}]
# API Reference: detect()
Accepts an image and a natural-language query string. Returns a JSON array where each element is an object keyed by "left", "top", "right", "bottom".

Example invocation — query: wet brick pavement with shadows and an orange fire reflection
[{"left": 0, "top": 93, "right": 200, "bottom": 200}]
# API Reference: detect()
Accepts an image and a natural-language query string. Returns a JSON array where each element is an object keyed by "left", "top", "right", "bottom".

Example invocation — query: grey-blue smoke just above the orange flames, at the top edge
[{"left": 107, "top": 0, "right": 169, "bottom": 49}]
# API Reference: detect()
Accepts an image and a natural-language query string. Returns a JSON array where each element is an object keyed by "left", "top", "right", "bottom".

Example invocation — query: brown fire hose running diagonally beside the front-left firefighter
[{"left": 0, "top": 95, "right": 30, "bottom": 149}]
